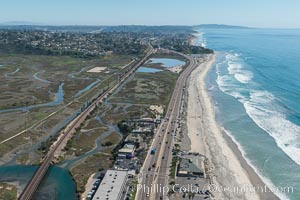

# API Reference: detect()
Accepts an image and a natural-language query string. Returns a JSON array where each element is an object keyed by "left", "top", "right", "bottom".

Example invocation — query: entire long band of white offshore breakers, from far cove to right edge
[{"left": 216, "top": 54, "right": 300, "bottom": 165}]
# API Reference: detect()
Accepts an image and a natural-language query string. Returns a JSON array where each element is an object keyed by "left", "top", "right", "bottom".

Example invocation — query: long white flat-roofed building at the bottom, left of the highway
[{"left": 93, "top": 170, "right": 128, "bottom": 200}]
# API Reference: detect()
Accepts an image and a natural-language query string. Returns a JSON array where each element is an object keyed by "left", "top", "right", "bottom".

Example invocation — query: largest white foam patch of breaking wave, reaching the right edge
[{"left": 244, "top": 91, "right": 300, "bottom": 165}]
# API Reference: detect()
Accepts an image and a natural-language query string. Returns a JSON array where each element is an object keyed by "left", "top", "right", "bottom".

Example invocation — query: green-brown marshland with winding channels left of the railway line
[{"left": 0, "top": 54, "right": 134, "bottom": 163}]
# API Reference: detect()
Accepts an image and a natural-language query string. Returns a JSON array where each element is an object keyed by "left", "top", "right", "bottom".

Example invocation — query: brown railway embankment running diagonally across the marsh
[{"left": 19, "top": 49, "right": 156, "bottom": 200}]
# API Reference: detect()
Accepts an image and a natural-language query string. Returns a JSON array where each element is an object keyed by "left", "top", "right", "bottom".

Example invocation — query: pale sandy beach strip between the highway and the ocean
[{"left": 186, "top": 55, "right": 278, "bottom": 200}]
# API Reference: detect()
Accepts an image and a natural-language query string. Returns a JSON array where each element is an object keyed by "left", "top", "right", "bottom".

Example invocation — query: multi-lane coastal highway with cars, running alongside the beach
[{"left": 136, "top": 53, "right": 202, "bottom": 200}]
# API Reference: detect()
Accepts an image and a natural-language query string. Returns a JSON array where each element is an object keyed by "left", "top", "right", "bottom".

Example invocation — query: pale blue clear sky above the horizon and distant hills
[{"left": 0, "top": 0, "right": 300, "bottom": 28}]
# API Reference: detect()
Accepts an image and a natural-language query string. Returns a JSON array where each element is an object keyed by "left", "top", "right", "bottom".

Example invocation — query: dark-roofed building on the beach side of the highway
[{"left": 177, "top": 158, "right": 204, "bottom": 177}]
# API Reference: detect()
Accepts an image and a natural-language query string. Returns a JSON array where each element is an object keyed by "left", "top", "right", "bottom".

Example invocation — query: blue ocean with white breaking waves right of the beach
[{"left": 194, "top": 29, "right": 300, "bottom": 200}]
